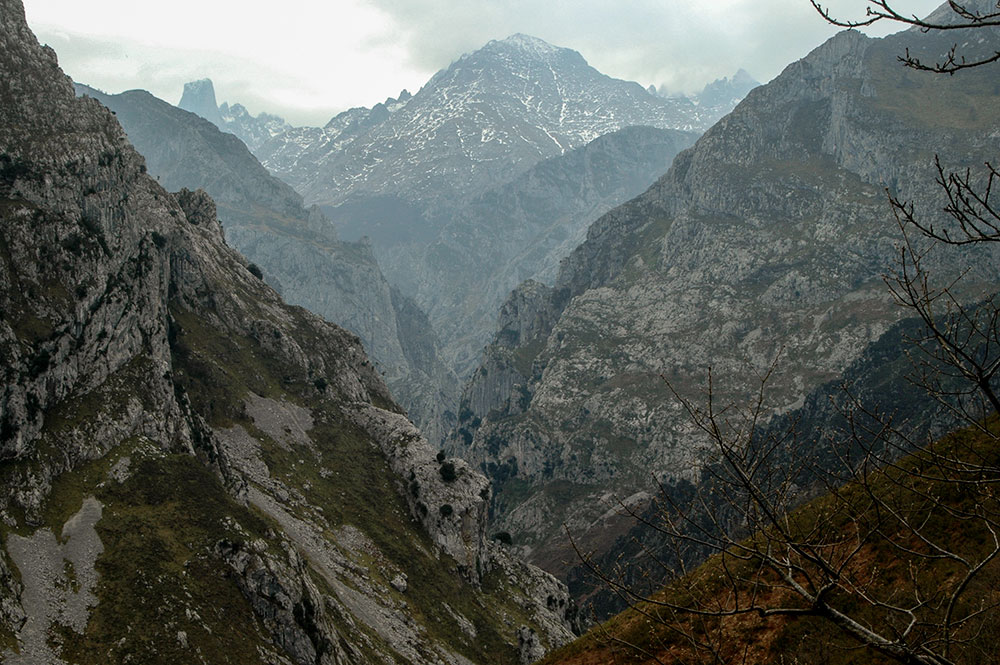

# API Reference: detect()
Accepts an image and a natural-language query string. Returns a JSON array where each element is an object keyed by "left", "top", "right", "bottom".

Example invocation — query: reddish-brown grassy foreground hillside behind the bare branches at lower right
[{"left": 542, "top": 419, "right": 1000, "bottom": 665}]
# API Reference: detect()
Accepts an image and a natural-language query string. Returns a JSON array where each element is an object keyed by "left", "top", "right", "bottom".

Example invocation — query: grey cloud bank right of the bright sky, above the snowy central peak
[{"left": 373, "top": 0, "right": 938, "bottom": 92}]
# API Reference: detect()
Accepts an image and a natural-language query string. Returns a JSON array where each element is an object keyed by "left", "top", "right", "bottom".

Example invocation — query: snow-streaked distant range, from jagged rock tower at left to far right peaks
[{"left": 179, "top": 33, "right": 759, "bottom": 179}]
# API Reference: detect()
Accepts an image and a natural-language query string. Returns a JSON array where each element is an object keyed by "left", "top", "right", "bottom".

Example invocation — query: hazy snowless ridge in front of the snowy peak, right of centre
[{"left": 383, "top": 127, "right": 697, "bottom": 376}]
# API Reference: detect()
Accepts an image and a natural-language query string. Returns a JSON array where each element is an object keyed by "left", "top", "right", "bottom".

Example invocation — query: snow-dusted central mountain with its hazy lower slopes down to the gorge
[{"left": 174, "top": 35, "right": 728, "bottom": 402}]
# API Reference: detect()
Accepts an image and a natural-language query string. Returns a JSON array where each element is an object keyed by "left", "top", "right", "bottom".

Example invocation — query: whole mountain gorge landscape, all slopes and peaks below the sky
[{"left": 0, "top": 0, "right": 1000, "bottom": 665}]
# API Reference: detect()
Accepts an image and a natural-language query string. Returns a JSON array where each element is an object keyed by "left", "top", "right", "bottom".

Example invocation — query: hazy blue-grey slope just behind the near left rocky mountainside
[{"left": 77, "top": 81, "right": 458, "bottom": 441}]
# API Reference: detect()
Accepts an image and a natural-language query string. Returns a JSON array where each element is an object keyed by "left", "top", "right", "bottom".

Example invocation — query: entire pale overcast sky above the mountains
[{"left": 24, "top": 0, "right": 940, "bottom": 125}]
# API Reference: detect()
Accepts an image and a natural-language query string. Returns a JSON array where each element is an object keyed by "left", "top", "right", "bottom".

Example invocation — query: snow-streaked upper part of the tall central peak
[{"left": 257, "top": 34, "right": 732, "bottom": 217}]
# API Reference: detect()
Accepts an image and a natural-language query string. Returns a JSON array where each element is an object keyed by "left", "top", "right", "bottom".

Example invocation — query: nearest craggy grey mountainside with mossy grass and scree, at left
[{"left": 0, "top": 0, "right": 572, "bottom": 665}]
